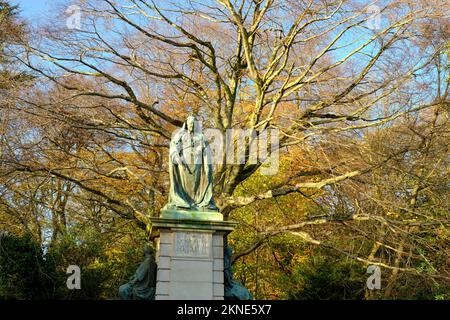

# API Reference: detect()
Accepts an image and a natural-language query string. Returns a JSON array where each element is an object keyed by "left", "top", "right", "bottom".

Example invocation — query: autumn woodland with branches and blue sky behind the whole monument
[{"left": 0, "top": 0, "right": 450, "bottom": 299}]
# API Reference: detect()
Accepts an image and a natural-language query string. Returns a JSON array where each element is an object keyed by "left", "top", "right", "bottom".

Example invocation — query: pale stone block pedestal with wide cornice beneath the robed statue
[{"left": 151, "top": 209, "right": 236, "bottom": 300}]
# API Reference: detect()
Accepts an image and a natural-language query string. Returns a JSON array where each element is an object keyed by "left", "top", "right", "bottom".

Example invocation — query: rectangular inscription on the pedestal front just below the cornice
[{"left": 174, "top": 231, "right": 212, "bottom": 258}]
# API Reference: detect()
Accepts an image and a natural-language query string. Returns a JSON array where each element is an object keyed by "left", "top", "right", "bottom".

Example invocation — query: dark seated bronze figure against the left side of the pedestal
[{"left": 119, "top": 246, "right": 157, "bottom": 300}]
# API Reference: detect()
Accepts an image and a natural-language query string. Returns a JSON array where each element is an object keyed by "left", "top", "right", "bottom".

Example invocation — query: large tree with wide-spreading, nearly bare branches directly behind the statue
[{"left": 2, "top": 0, "right": 448, "bottom": 298}]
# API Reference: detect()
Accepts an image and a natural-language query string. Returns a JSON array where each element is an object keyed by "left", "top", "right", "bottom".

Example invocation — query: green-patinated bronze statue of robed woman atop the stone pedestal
[{"left": 166, "top": 116, "right": 217, "bottom": 211}]
